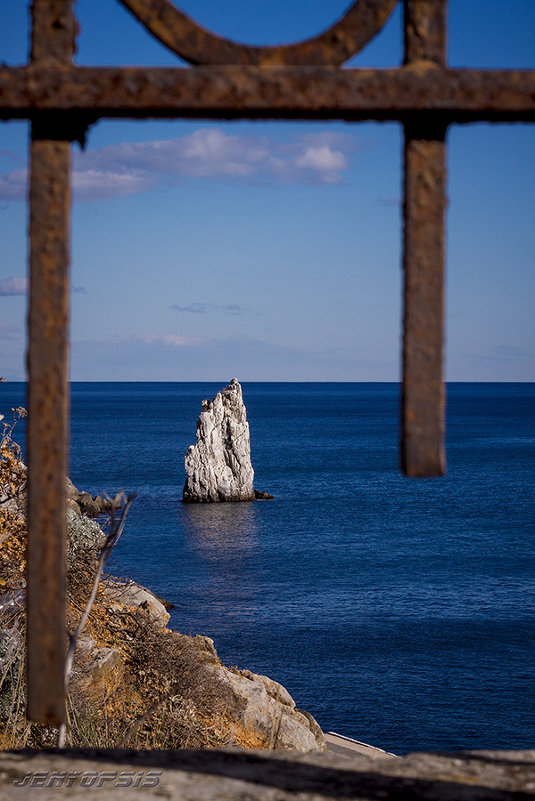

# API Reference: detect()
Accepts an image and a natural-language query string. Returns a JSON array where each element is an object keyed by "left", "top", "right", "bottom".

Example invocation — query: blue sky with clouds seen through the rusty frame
[{"left": 0, "top": 0, "right": 535, "bottom": 381}]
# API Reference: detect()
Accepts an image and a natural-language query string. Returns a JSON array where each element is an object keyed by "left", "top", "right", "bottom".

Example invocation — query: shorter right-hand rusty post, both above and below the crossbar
[{"left": 401, "top": 0, "right": 446, "bottom": 476}]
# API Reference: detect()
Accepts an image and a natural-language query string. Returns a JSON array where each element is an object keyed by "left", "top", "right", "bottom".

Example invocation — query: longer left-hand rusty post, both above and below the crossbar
[{"left": 27, "top": 0, "right": 75, "bottom": 725}]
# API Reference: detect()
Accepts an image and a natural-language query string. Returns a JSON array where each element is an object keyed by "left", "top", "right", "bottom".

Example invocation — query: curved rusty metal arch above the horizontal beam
[{"left": 120, "top": 0, "right": 397, "bottom": 67}]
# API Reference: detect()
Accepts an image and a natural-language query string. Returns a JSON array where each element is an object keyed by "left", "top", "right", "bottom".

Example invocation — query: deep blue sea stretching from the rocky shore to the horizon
[{"left": 0, "top": 383, "right": 535, "bottom": 753}]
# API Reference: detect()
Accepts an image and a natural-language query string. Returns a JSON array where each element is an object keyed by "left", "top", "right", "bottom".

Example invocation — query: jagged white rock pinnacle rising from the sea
[{"left": 182, "top": 378, "right": 255, "bottom": 503}]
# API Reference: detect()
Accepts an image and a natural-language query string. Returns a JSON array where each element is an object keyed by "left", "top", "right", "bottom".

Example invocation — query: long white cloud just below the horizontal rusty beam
[{"left": 0, "top": 127, "right": 356, "bottom": 200}]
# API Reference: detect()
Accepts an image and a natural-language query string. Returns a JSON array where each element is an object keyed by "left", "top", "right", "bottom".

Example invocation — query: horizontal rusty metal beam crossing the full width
[{"left": 0, "top": 62, "right": 535, "bottom": 124}]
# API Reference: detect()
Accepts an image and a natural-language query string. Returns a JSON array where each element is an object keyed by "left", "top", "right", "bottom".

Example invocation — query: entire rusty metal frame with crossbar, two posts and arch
[{"left": 0, "top": 0, "right": 535, "bottom": 725}]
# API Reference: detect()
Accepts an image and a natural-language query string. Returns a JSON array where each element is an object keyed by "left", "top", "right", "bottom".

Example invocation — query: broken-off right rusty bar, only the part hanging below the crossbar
[{"left": 401, "top": 131, "right": 446, "bottom": 476}]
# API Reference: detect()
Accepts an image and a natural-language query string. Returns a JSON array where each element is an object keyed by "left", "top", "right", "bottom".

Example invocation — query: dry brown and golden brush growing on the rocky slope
[{"left": 0, "top": 409, "right": 246, "bottom": 749}]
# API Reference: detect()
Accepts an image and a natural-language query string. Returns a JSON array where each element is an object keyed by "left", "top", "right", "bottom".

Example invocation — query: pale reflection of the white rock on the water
[{"left": 181, "top": 501, "right": 258, "bottom": 561}]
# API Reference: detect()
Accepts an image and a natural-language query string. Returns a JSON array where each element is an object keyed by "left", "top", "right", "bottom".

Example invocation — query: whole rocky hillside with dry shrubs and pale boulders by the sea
[{"left": 0, "top": 432, "right": 326, "bottom": 752}]
